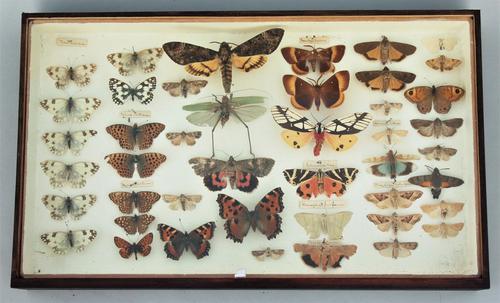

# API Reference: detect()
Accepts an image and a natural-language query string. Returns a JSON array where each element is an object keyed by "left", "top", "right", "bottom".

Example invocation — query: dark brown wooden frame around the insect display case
[{"left": 11, "top": 10, "right": 490, "bottom": 290}]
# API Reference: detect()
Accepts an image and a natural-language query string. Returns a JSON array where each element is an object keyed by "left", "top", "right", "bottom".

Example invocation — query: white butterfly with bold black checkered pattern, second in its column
[{"left": 109, "top": 77, "right": 156, "bottom": 105}]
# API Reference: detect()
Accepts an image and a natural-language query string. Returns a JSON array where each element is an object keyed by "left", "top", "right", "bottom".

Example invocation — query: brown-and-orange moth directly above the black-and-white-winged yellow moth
[{"left": 283, "top": 71, "right": 349, "bottom": 111}]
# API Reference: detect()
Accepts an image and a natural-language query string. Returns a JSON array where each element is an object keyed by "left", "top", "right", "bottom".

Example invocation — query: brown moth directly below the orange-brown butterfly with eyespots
[{"left": 410, "top": 118, "right": 464, "bottom": 138}]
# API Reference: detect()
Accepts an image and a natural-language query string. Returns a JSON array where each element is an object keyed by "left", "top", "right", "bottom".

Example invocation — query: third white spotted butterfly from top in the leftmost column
[{"left": 42, "top": 130, "right": 97, "bottom": 156}]
